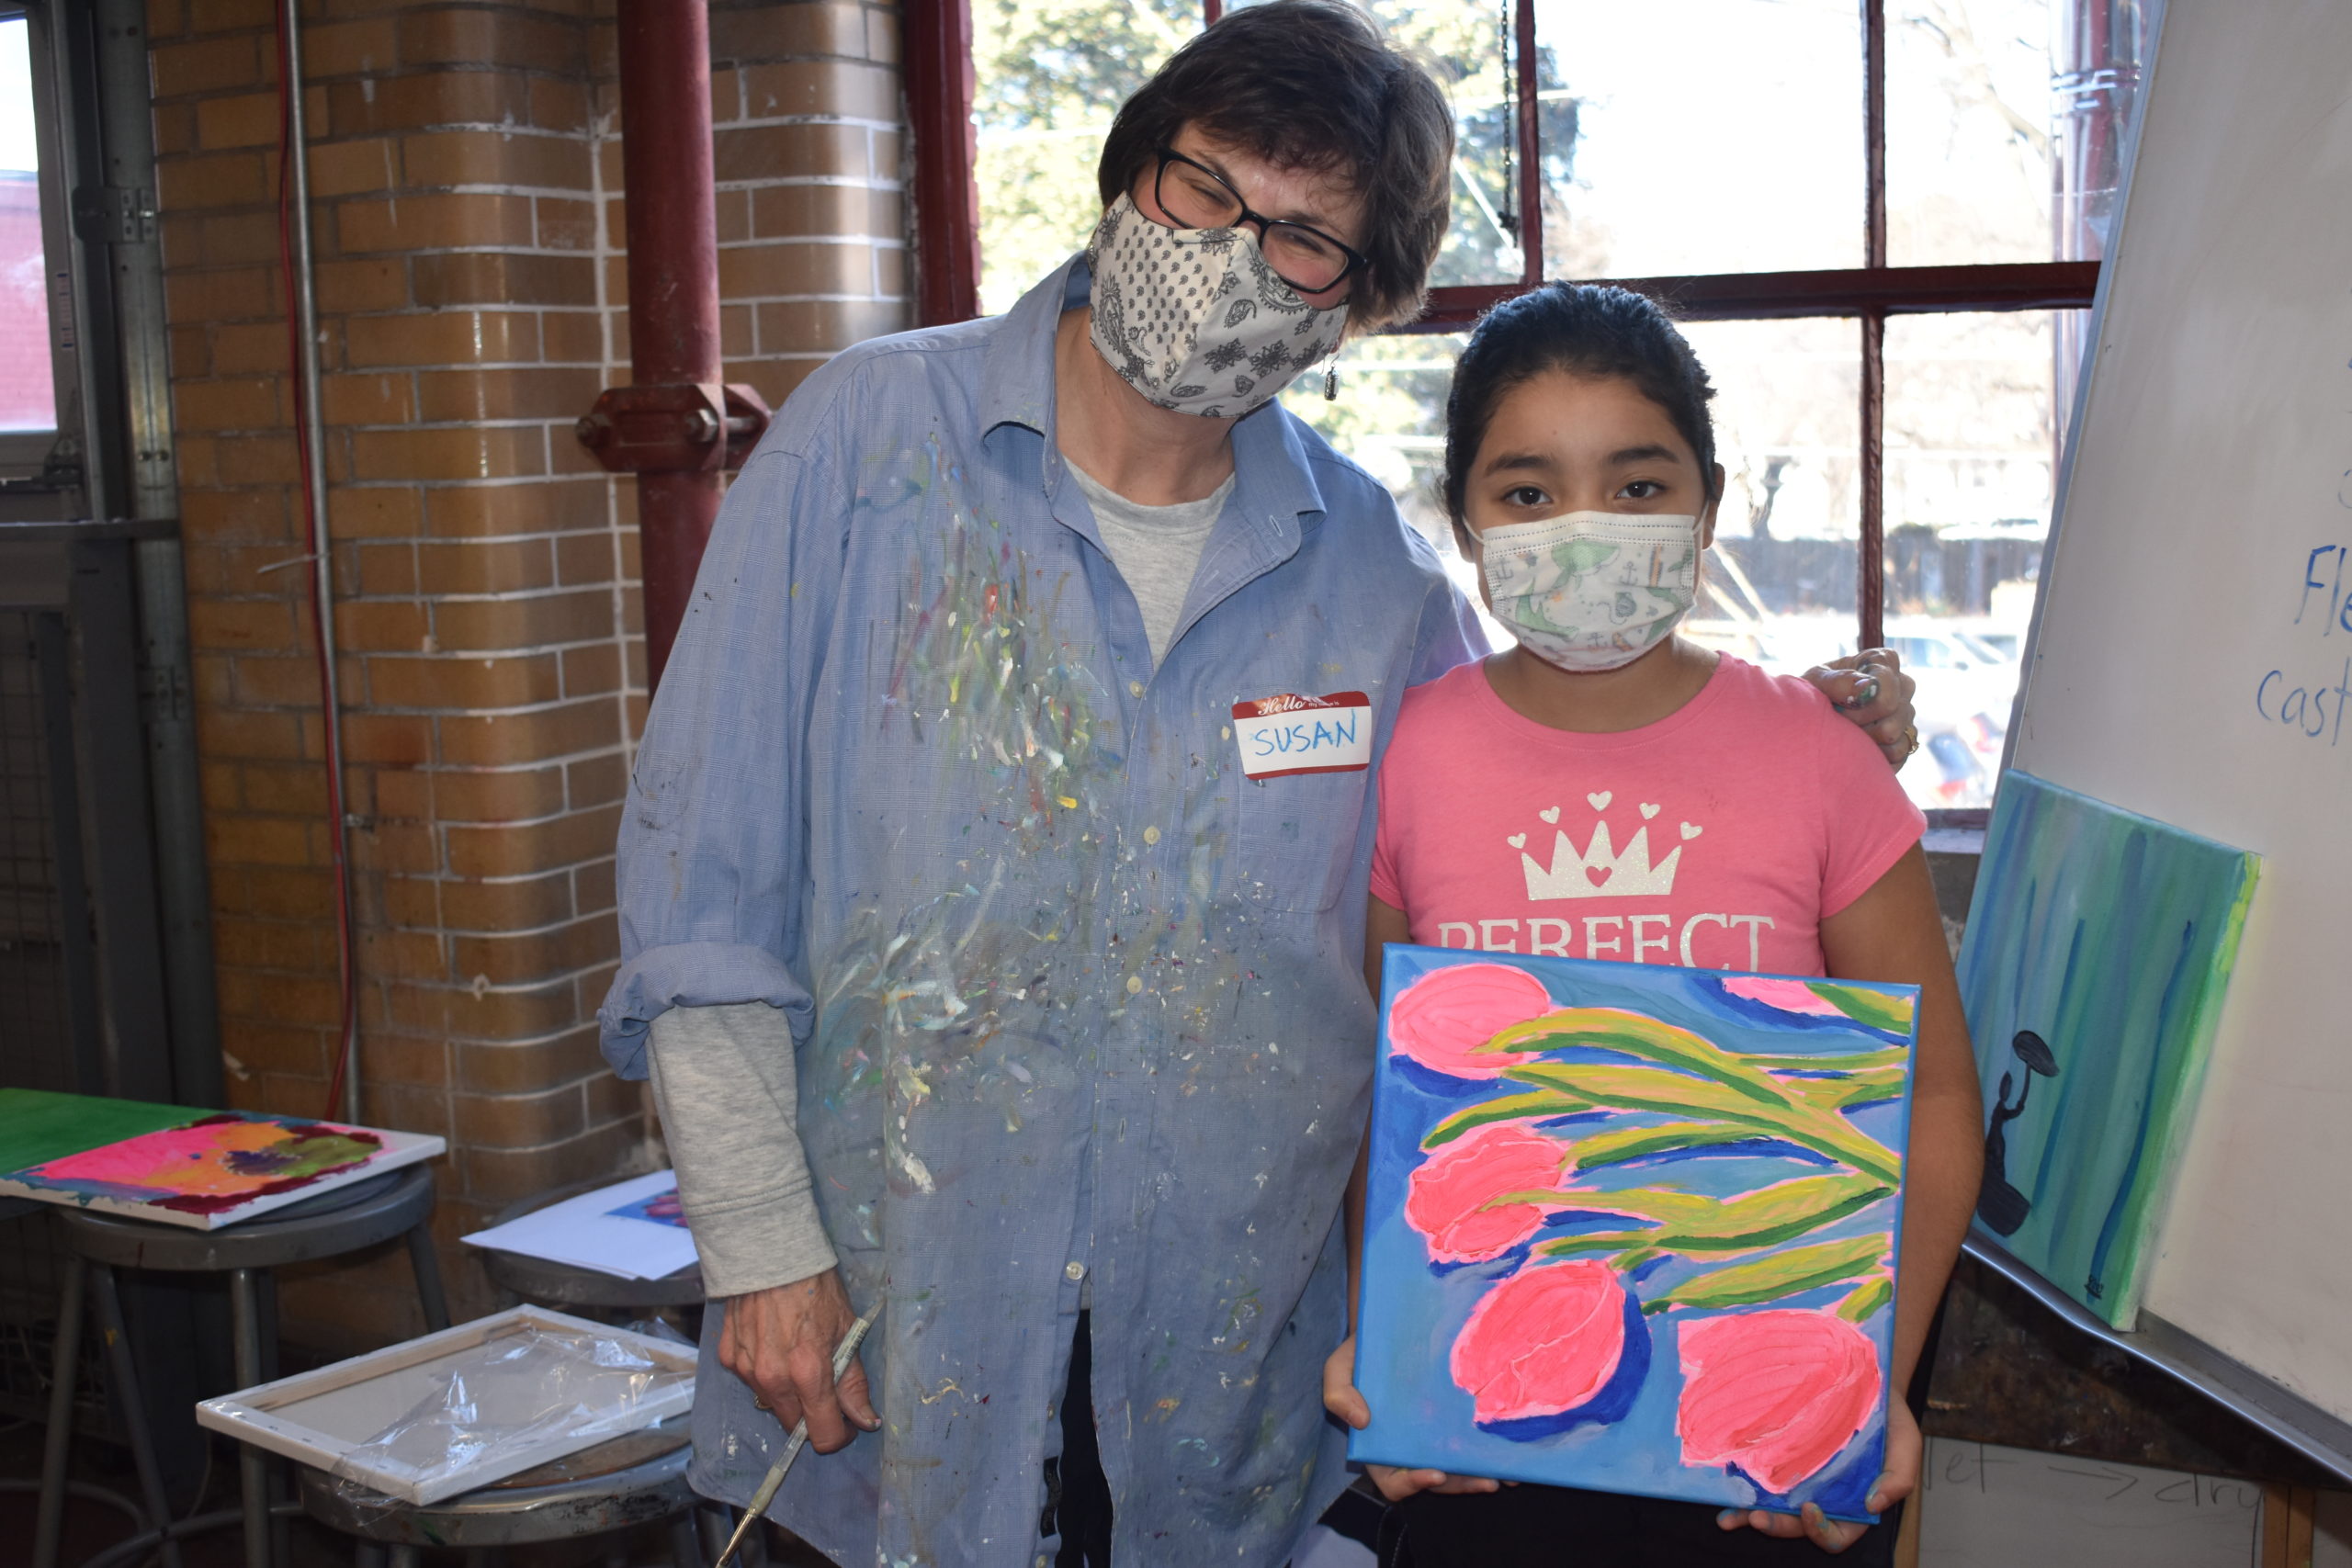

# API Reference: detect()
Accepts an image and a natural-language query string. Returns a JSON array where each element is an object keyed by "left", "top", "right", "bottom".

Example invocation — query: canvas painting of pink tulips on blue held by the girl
[{"left": 1350, "top": 945, "right": 1917, "bottom": 1518}]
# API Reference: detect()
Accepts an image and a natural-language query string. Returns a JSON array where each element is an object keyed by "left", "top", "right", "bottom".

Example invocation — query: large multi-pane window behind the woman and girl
[{"left": 950, "top": 0, "right": 2154, "bottom": 808}]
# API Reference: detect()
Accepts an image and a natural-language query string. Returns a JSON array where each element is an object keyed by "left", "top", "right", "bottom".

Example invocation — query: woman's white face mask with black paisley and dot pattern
[{"left": 1087, "top": 195, "right": 1348, "bottom": 419}]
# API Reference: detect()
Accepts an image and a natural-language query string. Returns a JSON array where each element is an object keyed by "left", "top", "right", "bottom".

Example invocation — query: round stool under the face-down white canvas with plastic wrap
[{"left": 297, "top": 1413, "right": 738, "bottom": 1568}]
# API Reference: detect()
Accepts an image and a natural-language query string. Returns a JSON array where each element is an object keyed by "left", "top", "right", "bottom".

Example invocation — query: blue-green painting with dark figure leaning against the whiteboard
[{"left": 1959, "top": 771, "right": 2260, "bottom": 1328}]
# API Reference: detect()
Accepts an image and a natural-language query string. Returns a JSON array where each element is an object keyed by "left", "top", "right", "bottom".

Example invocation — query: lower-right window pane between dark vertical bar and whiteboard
[{"left": 1886, "top": 310, "right": 2058, "bottom": 807}]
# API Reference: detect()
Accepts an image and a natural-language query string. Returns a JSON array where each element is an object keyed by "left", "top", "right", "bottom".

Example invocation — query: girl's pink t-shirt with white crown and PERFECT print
[{"left": 1371, "top": 653, "right": 1927, "bottom": 976}]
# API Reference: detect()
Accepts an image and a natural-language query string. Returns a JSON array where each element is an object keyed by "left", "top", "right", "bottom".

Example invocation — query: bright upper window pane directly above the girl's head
[{"left": 1536, "top": 0, "right": 1865, "bottom": 277}]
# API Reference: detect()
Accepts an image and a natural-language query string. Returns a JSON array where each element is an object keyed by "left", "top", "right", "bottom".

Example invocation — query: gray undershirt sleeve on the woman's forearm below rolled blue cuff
[{"left": 647, "top": 1001, "right": 835, "bottom": 1295}]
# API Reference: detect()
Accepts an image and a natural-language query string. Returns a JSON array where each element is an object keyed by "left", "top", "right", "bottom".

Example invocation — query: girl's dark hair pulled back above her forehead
[{"left": 1446, "top": 282, "right": 1714, "bottom": 525}]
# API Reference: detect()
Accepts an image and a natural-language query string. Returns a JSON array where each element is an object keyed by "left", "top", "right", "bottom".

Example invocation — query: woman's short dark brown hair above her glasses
[{"left": 1096, "top": 0, "right": 1453, "bottom": 329}]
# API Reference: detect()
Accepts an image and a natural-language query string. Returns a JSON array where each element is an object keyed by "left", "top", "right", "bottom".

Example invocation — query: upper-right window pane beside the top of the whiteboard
[{"left": 1886, "top": 0, "right": 2067, "bottom": 265}]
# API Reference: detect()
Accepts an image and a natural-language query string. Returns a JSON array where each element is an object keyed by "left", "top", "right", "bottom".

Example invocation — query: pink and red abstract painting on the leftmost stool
[{"left": 0, "top": 1090, "right": 445, "bottom": 1229}]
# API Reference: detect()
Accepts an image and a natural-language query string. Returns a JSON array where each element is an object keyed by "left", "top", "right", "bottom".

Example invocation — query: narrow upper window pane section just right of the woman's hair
[{"left": 1369, "top": 0, "right": 1523, "bottom": 287}]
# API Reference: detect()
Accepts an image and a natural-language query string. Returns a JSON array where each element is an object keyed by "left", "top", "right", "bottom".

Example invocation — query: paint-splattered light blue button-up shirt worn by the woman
[{"left": 602, "top": 261, "right": 1482, "bottom": 1568}]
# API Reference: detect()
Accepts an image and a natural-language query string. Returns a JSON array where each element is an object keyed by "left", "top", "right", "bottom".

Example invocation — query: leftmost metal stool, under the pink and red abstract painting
[{"left": 33, "top": 1166, "right": 449, "bottom": 1568}]
